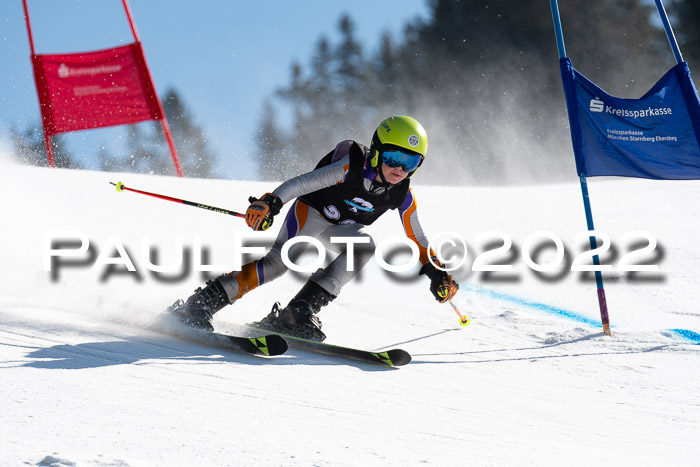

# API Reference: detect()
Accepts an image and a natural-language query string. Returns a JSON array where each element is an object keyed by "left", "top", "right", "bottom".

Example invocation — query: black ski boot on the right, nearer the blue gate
[{"left": 253, "top": 281, "right": 335, "bottom": 342}]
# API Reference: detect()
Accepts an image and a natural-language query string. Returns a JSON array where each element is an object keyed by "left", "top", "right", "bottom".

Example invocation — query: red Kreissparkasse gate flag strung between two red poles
[{"left": 32, "top": 42, "right": 163, "bottom": 136}]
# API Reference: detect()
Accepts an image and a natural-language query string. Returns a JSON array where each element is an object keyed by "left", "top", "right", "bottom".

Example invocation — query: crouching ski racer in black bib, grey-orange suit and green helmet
[{"left": 169, "top": 116, "right": 459, "bottom": 341}]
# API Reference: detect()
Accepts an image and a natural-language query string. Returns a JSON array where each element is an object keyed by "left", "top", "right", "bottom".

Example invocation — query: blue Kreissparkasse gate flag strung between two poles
[{"left": 560, "top": 57, "right": 700, "bottom": 180}]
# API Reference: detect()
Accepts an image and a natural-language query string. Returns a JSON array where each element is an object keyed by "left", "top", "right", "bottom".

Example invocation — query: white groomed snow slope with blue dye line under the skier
[{"left": 0, "top": 159, "right": 700, "bottom": 466}]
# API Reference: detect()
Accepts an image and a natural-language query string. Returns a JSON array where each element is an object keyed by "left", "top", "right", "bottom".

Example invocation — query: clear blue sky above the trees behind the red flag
[{"left": 0, "top": 0, "right": 428, "bottom": 179}]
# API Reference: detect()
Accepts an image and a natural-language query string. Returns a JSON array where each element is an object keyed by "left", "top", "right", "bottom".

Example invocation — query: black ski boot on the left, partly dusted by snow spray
[{"left": 167, "top": 279, "right": 230, "bottom": 332}]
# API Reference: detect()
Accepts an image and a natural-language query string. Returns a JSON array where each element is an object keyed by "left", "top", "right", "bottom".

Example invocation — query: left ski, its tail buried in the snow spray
[{"left": 157, "top": 325, "right": 288, "bottom": 357}]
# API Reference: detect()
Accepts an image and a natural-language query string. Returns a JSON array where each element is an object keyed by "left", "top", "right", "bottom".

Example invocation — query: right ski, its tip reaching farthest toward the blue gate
[{"left": 245, "top": 325, "right": 411, "bottom": 367}]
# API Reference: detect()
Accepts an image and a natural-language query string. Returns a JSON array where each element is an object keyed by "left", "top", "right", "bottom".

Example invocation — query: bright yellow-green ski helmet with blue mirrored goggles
[{"left": 370, "top": 115, "right": 428, "bottom": 178}]
